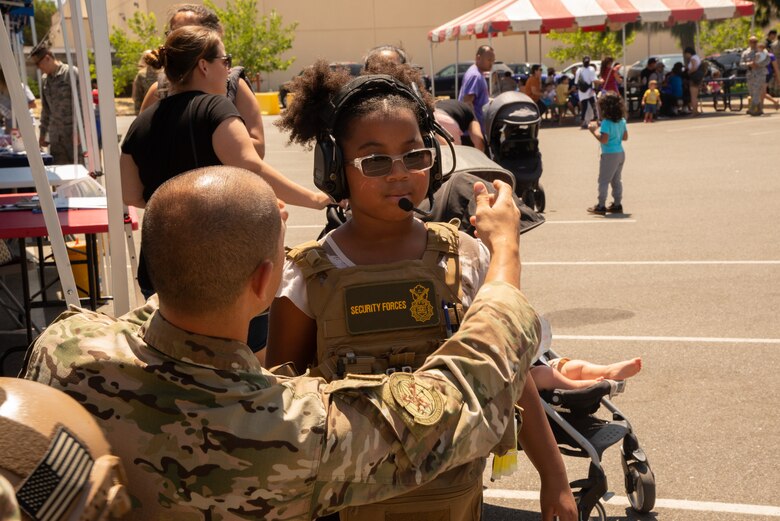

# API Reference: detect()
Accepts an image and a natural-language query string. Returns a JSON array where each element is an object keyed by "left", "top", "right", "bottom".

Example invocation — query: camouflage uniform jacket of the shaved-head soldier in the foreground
[{"left": 24, "top": 283, "right": 539, "bottom": 521}]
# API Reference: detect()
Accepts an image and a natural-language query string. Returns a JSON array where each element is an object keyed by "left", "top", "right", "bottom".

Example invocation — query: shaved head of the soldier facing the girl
[{"left": 141, "top": 166, "right": 282, "bottom": 315}]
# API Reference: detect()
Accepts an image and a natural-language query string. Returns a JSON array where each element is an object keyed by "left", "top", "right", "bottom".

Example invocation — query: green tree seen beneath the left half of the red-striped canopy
[{"left": 547, "top": 25, "right": 636, "bottom": 62}]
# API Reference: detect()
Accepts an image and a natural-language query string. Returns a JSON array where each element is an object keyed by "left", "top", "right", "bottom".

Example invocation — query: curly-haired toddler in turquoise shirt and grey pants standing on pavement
[{"left": 588, "top": 92, "right": 628, "bottom": 215}]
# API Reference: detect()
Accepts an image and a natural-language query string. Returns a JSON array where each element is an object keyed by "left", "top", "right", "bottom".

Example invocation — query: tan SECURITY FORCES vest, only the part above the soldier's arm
[{"left": 288, "top": 223, "right": 478, "bottom": 380}]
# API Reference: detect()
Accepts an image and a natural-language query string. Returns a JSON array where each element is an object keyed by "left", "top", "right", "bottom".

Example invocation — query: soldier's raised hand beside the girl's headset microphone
[{"left": 470, "top": 181, "right": 520, "bottom": 254}]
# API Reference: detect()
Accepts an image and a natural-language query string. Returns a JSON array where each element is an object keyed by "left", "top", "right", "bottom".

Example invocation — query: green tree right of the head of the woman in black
[{"left": 204, "top": 0, "right": 298, "bottom": 77}]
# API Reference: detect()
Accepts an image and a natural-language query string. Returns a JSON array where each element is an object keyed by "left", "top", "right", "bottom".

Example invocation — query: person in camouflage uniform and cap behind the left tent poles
[{"left": 30, "top": 47, "right": 78, "bottom": 165}]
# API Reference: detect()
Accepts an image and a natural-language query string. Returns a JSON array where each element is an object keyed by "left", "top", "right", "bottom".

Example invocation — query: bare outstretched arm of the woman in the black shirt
[{"left": 211, "top": 117, "right": 331, "bottom": 210}]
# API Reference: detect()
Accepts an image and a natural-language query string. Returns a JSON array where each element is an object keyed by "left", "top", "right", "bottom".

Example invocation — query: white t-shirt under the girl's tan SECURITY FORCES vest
[{"left": 276, "top": 222, "right": 490, "bottom": 319}]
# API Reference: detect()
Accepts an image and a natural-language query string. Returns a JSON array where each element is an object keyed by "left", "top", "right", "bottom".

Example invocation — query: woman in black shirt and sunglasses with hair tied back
[{"left": 120, "top": 25, "right": 331, "bottom": 294}]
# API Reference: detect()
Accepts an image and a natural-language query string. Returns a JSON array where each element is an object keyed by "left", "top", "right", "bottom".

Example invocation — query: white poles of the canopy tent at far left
[{"left": 0, "top": 0, "right": 130, "bottom": 315}]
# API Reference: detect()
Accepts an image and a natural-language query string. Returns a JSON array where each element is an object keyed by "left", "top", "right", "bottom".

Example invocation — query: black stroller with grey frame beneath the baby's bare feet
[{"left": 538, "top": 318, "right": 655, "bottom": 521}]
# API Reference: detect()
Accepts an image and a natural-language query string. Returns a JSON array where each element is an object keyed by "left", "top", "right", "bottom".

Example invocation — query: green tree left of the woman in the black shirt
[{"left": 109, "top": 11, "right": 162, "bottom": 96}]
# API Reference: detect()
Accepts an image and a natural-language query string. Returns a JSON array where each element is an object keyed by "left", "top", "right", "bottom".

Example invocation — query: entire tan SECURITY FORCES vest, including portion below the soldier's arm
[{"left": 287, "top": 223, "right": 484, "bottom": 521}]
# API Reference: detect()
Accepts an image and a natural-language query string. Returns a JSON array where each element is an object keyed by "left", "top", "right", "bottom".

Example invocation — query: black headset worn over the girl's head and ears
[{"left": 314, "top": 74, "right": 454, "bottom": 201}]
